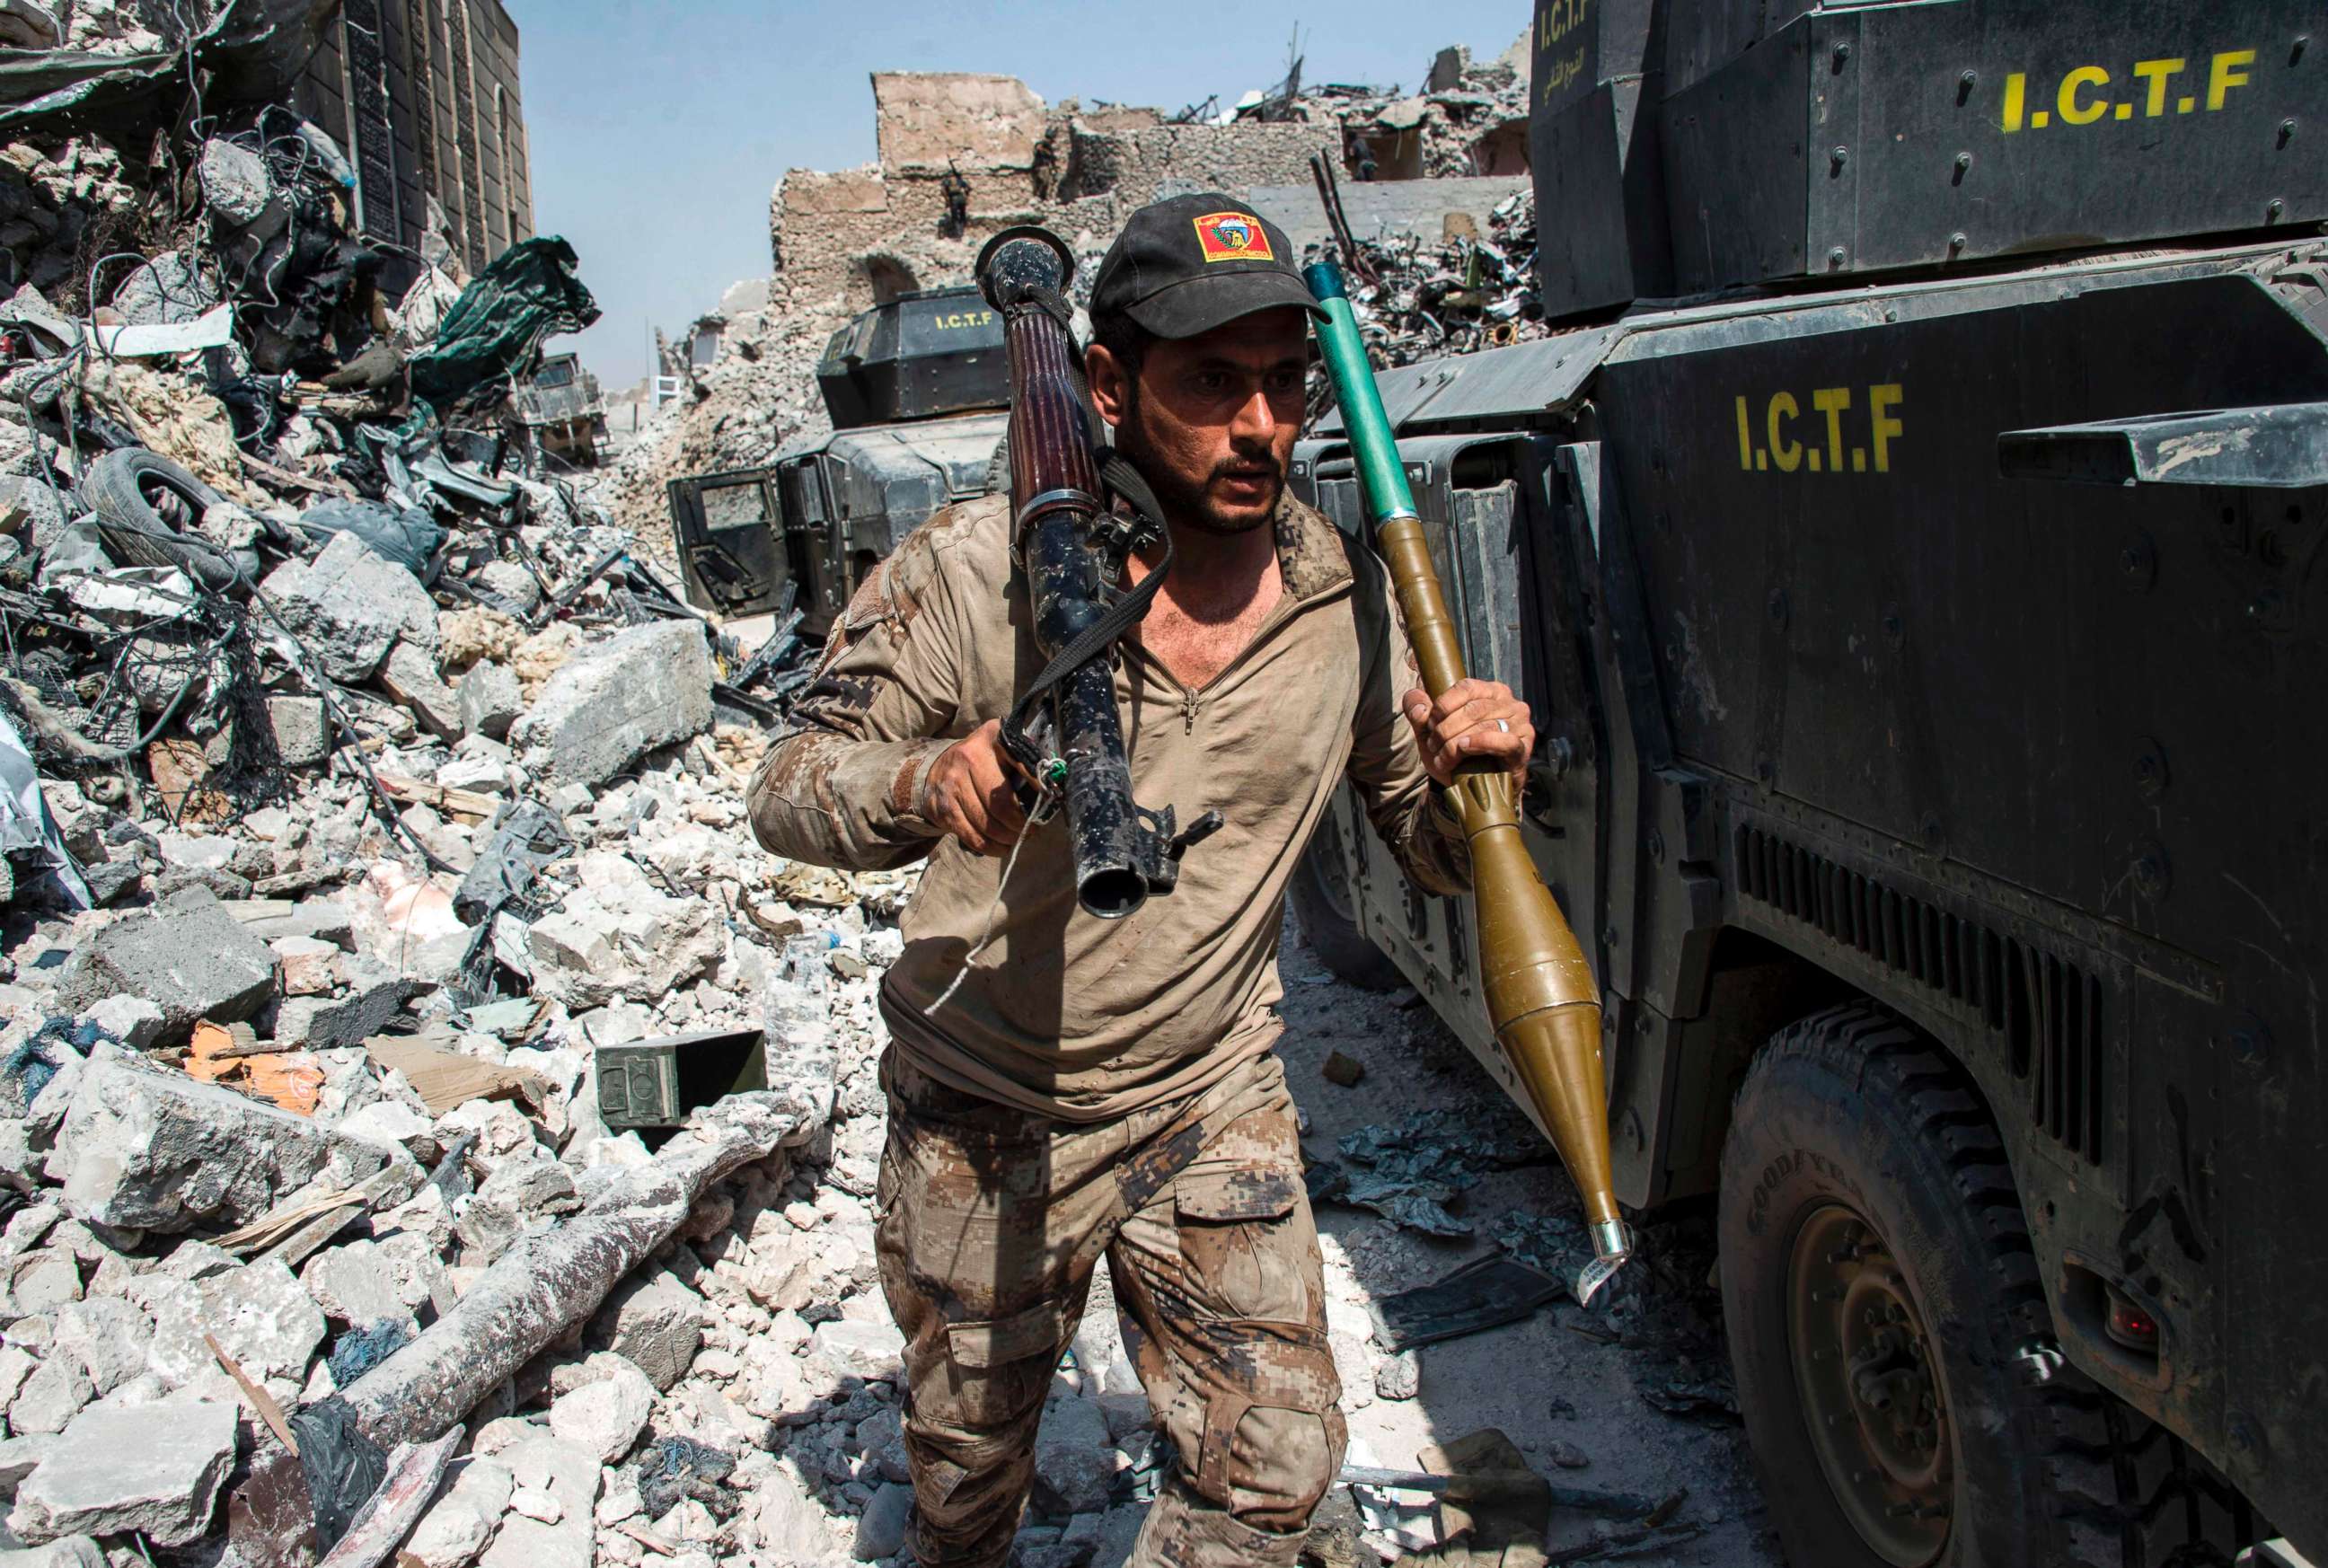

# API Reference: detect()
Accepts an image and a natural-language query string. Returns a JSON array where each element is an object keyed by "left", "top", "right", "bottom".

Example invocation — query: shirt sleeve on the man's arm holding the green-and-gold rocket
[{"left": 1348, "top": 568, "right": 1471, "bottom": 894}]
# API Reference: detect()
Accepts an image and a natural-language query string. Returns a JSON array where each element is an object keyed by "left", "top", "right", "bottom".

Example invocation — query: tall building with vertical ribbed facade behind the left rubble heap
[{"left": 294, "top": 0, "right": 534, "bottom": 281}]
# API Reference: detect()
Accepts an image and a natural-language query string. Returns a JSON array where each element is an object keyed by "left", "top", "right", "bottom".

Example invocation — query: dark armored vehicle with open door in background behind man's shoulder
[{"left": 670, "top": 288, "right": 1010, "bottom": 638}]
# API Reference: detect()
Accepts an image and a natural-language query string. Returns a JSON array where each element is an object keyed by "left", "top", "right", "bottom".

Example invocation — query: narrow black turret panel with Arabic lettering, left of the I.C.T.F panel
[{"left": 1527, "top": 0, "right": 1674, "bottom": 319}]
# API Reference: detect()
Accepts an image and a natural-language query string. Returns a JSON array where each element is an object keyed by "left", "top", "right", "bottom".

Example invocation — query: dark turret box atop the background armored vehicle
[{"left": 817, "top": 288, "right": 1010, "bottom": 430}]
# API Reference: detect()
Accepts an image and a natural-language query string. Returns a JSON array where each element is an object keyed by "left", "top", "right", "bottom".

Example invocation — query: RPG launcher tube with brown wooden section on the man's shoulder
[{"left": 978, "top": 225, "right": 1220, "bottom": 919}]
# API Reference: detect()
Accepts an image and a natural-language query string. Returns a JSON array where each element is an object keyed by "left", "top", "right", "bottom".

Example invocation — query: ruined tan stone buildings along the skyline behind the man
[{"left": 610, "top": 37, "right": 1534, "bottom": 549}]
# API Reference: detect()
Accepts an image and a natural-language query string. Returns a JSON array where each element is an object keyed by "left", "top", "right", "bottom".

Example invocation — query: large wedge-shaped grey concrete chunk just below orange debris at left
[{"left": 48, "top": 1051, "right": 393, "bottom": 1236}]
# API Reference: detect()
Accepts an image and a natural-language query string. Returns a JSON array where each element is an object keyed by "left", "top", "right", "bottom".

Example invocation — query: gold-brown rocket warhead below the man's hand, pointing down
[{"left": 1455, "top": 795, "right": 1632, "bottom": 1303}]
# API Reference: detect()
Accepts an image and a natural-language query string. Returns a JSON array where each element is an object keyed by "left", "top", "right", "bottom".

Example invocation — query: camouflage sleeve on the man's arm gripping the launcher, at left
[{"left": 745, "top": 535, "right": 961, "bottom": 870}]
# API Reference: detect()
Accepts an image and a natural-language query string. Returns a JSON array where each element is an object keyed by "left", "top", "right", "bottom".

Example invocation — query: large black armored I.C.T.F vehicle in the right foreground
[{"left": 1294, "top": 0, "right": 2328, "bottom": 1568}]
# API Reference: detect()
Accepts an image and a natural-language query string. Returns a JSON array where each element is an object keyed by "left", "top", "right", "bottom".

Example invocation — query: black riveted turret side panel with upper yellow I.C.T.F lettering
[{"left": 1662, "top": 0, "right": 2328, "bottom": 293}]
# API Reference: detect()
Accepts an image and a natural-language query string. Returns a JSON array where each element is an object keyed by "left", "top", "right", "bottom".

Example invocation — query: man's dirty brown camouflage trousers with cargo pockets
[{"left": 876, "top": 1052, "right": 1345, "bottom": 1568}]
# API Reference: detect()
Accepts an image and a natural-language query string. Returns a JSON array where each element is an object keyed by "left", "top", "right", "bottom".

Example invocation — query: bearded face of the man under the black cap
[{"left": 1087, "top": 304, "right": 1309, "bottom": 533}]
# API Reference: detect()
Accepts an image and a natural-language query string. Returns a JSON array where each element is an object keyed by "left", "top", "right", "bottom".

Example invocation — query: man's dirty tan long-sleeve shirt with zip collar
[{"left": 750, "top": 496, "right": 1471, "bottom": 1122}]
